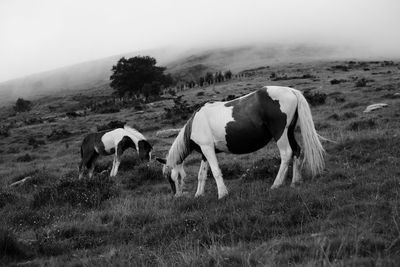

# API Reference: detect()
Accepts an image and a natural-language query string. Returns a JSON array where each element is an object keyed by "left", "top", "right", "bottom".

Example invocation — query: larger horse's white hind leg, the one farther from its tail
[{"left": 271, "top": 129, "right": 293, "bottom": 189}]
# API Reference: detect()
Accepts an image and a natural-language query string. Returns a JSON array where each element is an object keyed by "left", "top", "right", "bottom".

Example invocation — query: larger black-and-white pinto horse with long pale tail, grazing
[{"left": 157, "top": 86, "right": 324, "bottom": 198}]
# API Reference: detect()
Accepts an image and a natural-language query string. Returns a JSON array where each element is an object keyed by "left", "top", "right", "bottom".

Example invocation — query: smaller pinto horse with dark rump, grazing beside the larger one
[{"left": 79, "top": 125, "right": 152, "bottom": 179}]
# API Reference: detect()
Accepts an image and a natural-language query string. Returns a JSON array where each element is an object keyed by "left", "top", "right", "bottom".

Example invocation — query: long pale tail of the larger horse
[{"left": 292, "top": 89, "right": 325, "bottom": 176}]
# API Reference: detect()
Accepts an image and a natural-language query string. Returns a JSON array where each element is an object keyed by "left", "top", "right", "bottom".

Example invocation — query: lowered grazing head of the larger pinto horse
[{"left": 156, "top": 158, "right": 186, "bottom": 196}]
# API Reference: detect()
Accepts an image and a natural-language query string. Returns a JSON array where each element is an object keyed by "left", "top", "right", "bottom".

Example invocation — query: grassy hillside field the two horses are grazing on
[{"left": 0, "top": 61, "right": 400, "bottom": 266}]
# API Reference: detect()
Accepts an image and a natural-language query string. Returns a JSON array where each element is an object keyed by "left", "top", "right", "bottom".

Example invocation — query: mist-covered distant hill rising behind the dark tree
[{"left": 0, "top": 45, "right": 356, "bottom": 104}]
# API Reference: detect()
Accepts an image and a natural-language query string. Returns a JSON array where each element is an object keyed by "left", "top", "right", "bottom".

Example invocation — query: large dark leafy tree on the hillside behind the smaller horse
[{"left": 110, "top": 56, "right": 173, "bottom": 96}]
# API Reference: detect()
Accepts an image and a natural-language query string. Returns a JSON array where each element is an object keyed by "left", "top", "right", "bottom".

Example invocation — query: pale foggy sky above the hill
[{"left": 0, "top": 0, "right": 400, "bottom": 82}]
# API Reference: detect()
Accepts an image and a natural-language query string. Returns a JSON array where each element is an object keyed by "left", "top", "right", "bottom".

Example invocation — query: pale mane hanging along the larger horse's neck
[{"left": 167, "top": 115, "right": 194, "bottom": 167}]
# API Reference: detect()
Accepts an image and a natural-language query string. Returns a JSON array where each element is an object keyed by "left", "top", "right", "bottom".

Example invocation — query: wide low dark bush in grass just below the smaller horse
[{"left": 32, "top": 177, "right": 119, "bottom": 208}]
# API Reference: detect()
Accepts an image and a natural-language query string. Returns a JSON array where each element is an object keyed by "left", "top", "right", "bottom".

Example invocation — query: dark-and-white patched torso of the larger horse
[{"left": 192, "top": 86, "right": 297, "bottom": 154}]
